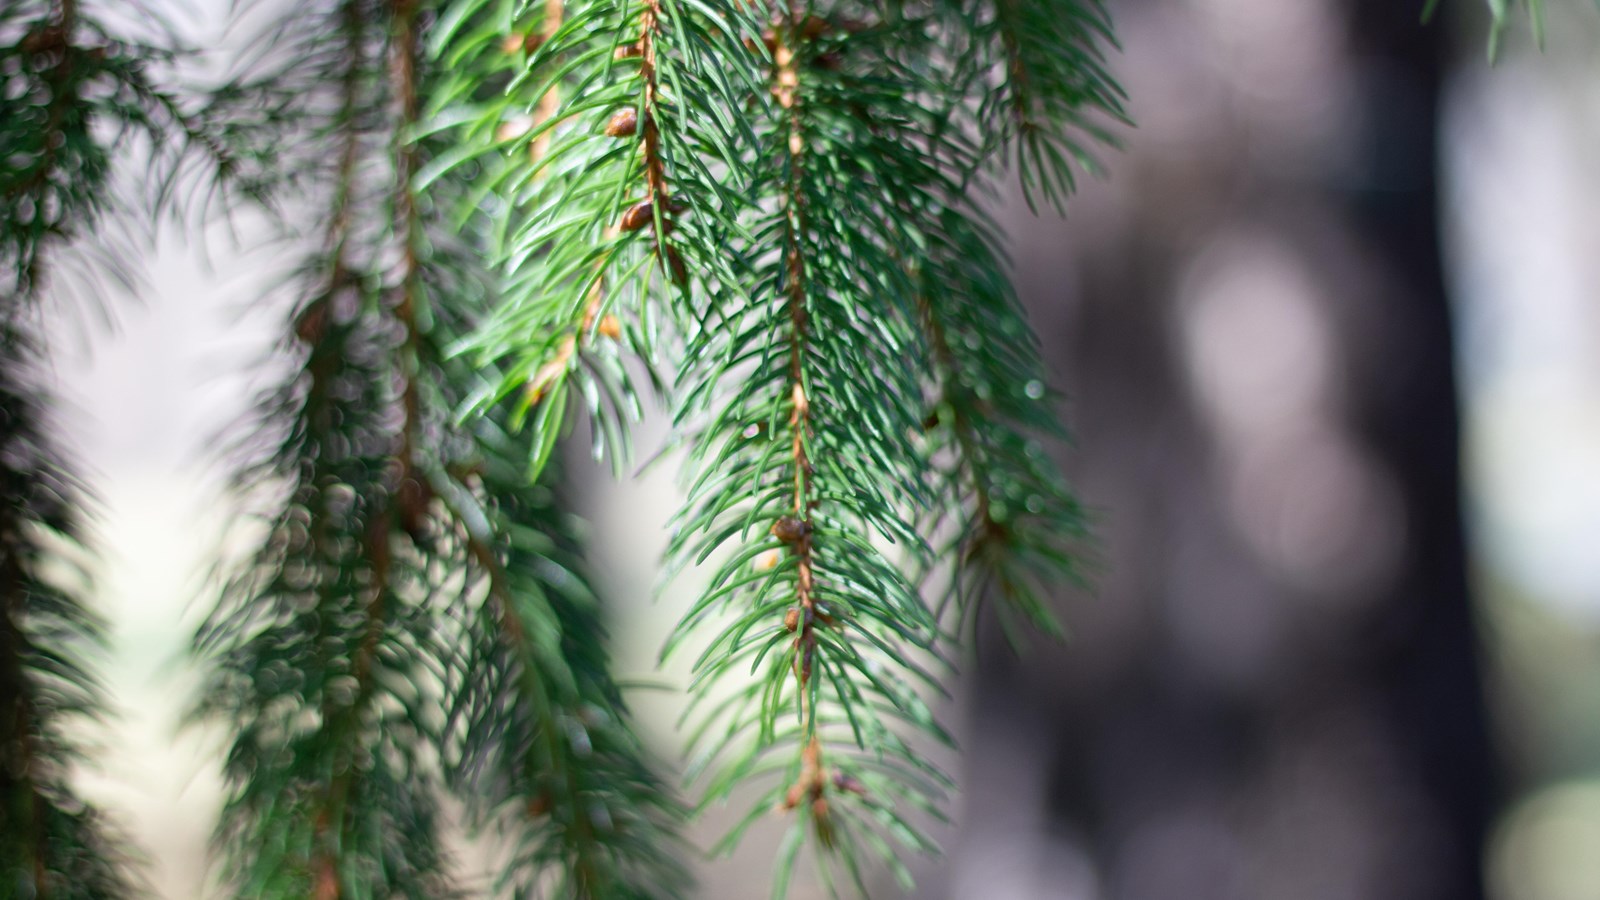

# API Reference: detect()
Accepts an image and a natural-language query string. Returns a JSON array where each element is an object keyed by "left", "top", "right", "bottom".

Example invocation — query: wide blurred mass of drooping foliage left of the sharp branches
[{"left": 188, "top": 0, "right": 686, "bottom": 898}]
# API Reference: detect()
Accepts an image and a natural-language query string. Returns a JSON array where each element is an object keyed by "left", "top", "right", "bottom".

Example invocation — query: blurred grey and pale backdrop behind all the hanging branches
[{"left": 34, "top": 0, "right": 1600, "bottom": 900}]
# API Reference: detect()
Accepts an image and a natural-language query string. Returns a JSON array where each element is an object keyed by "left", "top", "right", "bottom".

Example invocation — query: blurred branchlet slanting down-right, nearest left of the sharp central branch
[{"left": 443, "top": 408, "right": 690, "bottom": 900}]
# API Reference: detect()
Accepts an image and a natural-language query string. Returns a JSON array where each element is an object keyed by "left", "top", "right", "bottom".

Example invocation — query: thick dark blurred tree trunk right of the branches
[{"left": 953, "top": 0, "right": 1494, "bottom": 900}]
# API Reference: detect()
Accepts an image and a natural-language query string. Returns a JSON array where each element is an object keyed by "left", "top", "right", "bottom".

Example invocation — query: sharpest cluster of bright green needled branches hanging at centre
[{"left": 435, "top": 0, "right": 1123, "bottom": 892}]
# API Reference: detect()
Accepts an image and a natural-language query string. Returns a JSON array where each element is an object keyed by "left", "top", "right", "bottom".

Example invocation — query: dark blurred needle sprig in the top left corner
[{"left": 0, "top": 0, "right": 243, "bottom": 303}]
